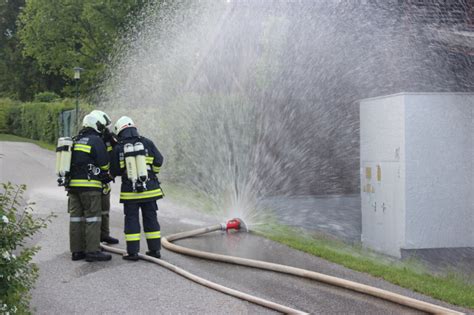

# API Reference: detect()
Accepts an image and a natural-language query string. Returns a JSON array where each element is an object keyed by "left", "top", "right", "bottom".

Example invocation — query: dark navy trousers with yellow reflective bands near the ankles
[{"left": 124, "top": 201, "right": 161, "bottom": 254}]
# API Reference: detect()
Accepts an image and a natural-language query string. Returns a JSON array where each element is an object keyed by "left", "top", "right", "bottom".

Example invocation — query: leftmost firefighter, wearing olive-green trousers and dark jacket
[{"left": 66, "top": 115, "right": 112, "bottom": 262}]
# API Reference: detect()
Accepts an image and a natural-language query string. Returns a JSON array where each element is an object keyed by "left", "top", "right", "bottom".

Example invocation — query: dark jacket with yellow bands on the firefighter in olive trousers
[{"left": 67, "top": 128, "right": 110, "bottom": 191}]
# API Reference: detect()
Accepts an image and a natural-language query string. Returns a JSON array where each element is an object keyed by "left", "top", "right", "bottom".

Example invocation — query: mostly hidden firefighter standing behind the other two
[{"left": 90, "top": 110, "right": 119, "bottom": 244}]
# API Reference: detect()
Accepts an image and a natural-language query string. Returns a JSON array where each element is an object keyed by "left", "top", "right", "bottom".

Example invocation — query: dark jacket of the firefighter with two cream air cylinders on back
[{"left": 110, "top": 127, "right": 163, "bottom": 203}]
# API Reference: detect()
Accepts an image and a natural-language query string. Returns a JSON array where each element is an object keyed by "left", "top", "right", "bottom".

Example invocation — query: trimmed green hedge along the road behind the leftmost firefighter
[{"left": 0, "top": 98, "right": 92, "bottom": 143}]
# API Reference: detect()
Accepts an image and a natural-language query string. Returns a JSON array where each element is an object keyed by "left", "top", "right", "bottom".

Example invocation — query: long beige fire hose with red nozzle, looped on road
[{"left": 101, "top": 219, "right": 463, "bottom": 314}]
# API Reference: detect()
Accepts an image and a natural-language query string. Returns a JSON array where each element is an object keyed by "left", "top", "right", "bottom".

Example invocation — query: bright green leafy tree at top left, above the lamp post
[{"left": 19, "top": 0, "right": 146, "bottom": 93}]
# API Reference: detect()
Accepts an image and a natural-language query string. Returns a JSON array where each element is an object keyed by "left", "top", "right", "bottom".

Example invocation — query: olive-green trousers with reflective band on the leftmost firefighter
[{"left": 68, "top": 191, "right": 102, "bottom": 253}]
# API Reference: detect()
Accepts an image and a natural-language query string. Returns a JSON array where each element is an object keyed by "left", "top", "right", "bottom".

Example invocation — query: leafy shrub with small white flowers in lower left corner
[{"left": 0, "top": 183, "right": 51, "bottom": 314}]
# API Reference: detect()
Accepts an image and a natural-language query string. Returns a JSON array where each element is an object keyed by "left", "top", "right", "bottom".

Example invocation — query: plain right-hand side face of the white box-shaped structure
[{"left": 404, "top": 93, "right": 474, "bottom": 248}]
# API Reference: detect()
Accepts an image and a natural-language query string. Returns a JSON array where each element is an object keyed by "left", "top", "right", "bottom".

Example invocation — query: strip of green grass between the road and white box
[{"left": 257, "top": 225, "right": 474, "bottom": 309}]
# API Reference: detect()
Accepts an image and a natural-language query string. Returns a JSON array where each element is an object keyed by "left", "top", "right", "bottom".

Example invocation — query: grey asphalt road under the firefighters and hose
[{"left": 0, "top": 142, "right": 466, "bottom": 314}]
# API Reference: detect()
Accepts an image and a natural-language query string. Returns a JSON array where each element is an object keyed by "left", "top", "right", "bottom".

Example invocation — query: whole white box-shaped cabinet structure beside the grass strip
[{"left": 360, "top": 93, "right": 474, "bottom": 256}]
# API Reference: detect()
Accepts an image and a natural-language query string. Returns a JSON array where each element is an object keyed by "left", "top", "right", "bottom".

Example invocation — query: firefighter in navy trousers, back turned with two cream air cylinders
[{"left": 111, "top": 116, "right": 163, "bottom": 261}]
